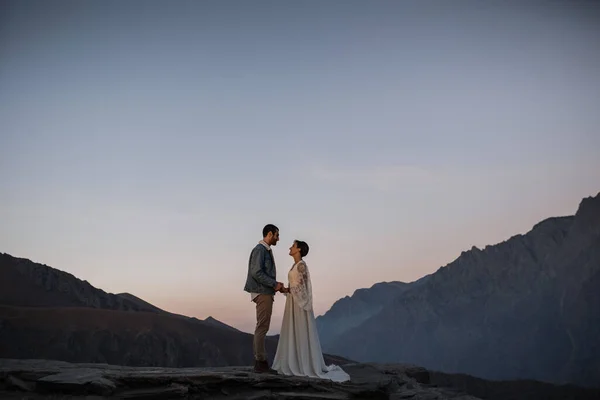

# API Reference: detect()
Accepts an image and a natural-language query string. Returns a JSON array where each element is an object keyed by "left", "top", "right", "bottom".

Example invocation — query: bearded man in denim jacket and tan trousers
[{"left": 244, "top": 224, "right": 283, "bottom": 374}]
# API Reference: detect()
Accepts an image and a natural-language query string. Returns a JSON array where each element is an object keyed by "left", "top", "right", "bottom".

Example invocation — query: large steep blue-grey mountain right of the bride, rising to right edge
[{"left": 322, "top": 194, "right": 600, "bottom": 385}]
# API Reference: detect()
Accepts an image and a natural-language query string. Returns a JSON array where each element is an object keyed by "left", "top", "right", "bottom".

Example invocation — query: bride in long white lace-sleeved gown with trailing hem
[{"left": 273, "top": 240, "right": 350, "bottom": 382}]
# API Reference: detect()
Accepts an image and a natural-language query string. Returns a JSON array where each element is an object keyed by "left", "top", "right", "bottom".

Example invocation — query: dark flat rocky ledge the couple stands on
[{"left": 0, "top": 359, "right": 477, "bottom": 400}]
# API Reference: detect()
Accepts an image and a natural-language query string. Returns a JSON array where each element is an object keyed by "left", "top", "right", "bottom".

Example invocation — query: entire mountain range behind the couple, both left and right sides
[{"left": 0, "top": 193, "right": 600, "bottom": 386}]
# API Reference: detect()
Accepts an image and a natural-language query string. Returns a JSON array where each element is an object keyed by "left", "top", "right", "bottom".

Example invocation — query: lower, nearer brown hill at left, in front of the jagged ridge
[{"left": 0, "top": 306, "right": 264, "bottom": 367}]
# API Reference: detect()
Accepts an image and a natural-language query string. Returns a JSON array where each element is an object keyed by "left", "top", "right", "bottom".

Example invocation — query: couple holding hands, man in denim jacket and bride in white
[{"left": 244, "top": 224, "right": 350, "bottom": 382}]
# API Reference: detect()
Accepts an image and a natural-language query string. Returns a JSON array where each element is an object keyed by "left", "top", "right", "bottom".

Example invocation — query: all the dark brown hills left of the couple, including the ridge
[{"left": 0, "top": 254, "right": 348, "bottom": 367}]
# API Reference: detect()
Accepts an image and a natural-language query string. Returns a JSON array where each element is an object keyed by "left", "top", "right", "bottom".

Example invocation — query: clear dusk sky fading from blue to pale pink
[{"left": 0, "top": 0, "right": 600, "bottom": 334}]
